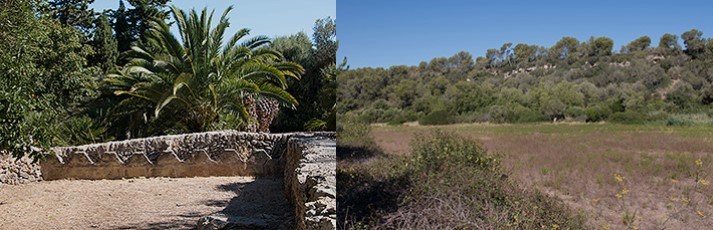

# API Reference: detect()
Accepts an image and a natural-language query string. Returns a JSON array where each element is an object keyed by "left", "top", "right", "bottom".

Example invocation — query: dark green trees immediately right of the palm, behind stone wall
[{"left": 271, "top": 17, "right": 340, "bottom": 132}]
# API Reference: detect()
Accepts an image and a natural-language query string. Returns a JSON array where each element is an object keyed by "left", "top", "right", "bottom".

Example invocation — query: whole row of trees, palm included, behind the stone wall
[{"left": 0, "top": 0, "right": 338, "bottom": 159}]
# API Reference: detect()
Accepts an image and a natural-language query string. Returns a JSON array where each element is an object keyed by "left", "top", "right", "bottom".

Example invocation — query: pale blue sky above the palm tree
[{"left": 92, "top": 0, "right": 336, "bottom": 37}]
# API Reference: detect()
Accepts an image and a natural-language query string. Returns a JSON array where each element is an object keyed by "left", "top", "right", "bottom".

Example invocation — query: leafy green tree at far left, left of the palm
[{"left": 0, "top": 0, "right": 98, "bottom": 159}]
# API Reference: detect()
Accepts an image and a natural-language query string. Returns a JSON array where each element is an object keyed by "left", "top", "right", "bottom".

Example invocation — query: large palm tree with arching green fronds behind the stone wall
[{"left": 105, "top": 6, "right": 304, "bottom": 135}]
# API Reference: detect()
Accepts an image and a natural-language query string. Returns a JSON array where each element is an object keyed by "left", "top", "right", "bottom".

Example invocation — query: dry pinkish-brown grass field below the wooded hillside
[{"left": 371, "top": 123, "right": 713, "bottom": 229}]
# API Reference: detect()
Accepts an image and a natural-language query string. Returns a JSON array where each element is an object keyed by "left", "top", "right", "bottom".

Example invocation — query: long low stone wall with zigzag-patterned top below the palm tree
[{"left": 41, "top": 131, "right": 294, "bottom": 180}]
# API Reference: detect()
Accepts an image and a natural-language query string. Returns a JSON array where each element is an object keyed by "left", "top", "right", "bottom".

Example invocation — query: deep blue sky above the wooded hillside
[{"left": 337, "top": 0, "right": 713, "bottom": 68}]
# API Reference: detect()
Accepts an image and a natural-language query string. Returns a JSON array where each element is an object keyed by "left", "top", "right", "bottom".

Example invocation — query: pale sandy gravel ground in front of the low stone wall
[{"left": 0, "top": 177, "right": 290, "bottom": 229}]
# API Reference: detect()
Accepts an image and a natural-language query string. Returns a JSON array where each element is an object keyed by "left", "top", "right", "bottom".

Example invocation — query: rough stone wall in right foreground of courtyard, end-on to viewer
[{"left": 285, "top": 133, "right": 337, "bottom": 229}]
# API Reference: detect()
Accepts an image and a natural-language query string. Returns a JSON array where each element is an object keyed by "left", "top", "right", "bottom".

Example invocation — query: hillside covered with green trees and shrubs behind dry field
[{"left": 337, "top": 29, "right": 713, "bottom": 124}]
